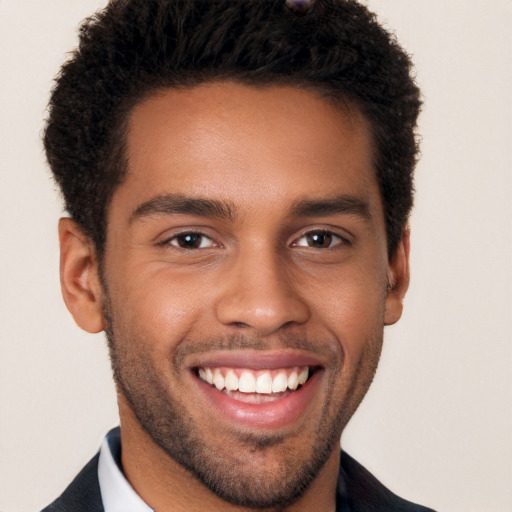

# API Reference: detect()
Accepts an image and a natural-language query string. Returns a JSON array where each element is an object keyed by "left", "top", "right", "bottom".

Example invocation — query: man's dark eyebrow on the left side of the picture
[{"left": 130, "top": 194, "right": 235, "bottom": 224}]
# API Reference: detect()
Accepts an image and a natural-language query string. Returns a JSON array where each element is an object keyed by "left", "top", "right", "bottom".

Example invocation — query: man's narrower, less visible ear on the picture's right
[{"left": 384, "top": 228, "right": 410, "bottom": 325}]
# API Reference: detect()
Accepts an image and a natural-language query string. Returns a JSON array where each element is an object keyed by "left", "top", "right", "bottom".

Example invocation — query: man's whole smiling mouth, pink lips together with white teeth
[{"left": 189, "top": 349, "right": 326, "bottom": 433}]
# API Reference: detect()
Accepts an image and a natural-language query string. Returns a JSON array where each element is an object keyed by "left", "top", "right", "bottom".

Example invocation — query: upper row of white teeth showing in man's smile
[{"left": 198, "top": 366, "right": 309, "bottom": 395}]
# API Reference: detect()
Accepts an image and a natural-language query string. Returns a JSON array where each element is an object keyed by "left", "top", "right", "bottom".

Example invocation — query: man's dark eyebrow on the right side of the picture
[{"left": 292, "top": 195, "right": 372, "bottom": 220}]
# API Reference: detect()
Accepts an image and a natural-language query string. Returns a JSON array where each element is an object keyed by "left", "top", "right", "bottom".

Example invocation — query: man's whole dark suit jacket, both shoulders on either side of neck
[{"left": 42, "top": 429, "right": 434, "bottom": 512}]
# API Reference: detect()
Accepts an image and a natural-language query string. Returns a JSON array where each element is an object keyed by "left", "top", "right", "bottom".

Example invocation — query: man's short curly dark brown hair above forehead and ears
[{"left": 44, "top": 0, "right": 421, "bottom": 256}]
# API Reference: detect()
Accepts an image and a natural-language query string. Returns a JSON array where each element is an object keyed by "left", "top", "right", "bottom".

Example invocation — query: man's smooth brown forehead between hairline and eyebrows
[{"left": 113, "top": 82, "right": 380, "bottom": 220}]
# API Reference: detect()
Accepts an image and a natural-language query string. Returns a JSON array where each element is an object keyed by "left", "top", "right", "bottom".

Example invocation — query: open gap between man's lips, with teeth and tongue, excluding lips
[{"left": 196, "top": 366, "right": 314, "bottom": 403}]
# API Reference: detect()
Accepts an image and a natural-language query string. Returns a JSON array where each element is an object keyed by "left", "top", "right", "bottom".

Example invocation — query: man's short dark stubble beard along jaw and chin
[{"left": 103, "top": 296, "right": 382, "bottom": 512}]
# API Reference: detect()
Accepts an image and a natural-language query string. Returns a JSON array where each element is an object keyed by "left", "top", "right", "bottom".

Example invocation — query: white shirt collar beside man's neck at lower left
[{"left": 98, "top": 432, "right": 153, "bottom": 512}]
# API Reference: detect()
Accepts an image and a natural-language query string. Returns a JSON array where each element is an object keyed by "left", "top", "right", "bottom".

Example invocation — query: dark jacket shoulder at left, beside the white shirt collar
[{"left": 42, "top": 454, "right": 104, "bottom": 512}]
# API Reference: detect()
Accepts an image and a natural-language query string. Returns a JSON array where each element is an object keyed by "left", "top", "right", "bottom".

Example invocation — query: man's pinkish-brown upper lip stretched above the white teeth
[{"left": 188, "top": 349, "right": 324, "bottom": 370}]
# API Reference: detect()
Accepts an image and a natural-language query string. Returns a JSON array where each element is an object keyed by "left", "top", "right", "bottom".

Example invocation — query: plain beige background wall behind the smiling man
[{"left": 0, "top": 0, "right": 512, "bottom": 512}]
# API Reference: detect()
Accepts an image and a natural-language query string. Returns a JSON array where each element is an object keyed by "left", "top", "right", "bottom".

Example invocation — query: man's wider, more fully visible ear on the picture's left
[{"left": 59, "top": 218, "right": 105, "bottom": 333}]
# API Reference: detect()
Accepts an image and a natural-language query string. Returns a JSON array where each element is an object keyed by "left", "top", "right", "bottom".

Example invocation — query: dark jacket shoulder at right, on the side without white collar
[{"left": 339, "top": 451, "right": 434, "bottom": 512}]
